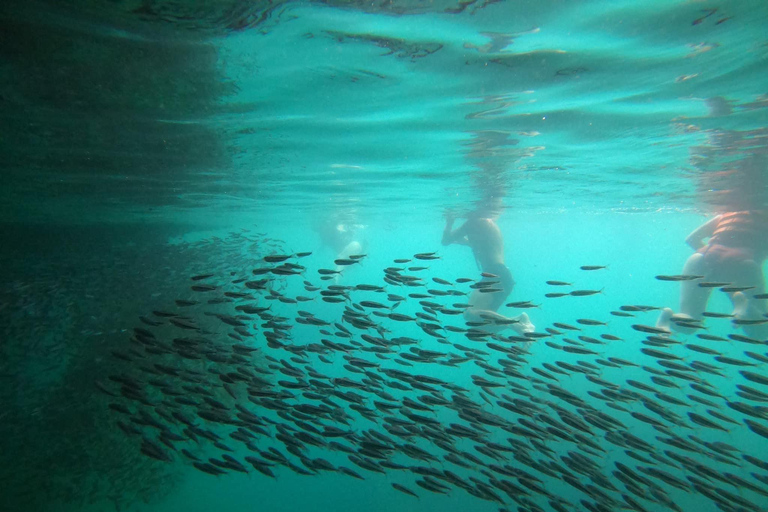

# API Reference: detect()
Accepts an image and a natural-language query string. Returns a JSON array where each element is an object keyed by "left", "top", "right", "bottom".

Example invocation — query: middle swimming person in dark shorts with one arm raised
[{"left": 442, "top": 206, "right": 534, "bottom": 334}]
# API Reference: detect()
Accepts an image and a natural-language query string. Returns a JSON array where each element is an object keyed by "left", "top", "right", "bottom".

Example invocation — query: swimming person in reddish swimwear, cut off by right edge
[{"left": 656, "top": 210, "right": 768, "bottom": 337}]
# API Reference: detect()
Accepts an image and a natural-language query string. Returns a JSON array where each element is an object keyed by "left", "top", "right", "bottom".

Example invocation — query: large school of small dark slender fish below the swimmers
[{"left": 95, "top": 241, "right": 768, "bottom": 512}]
